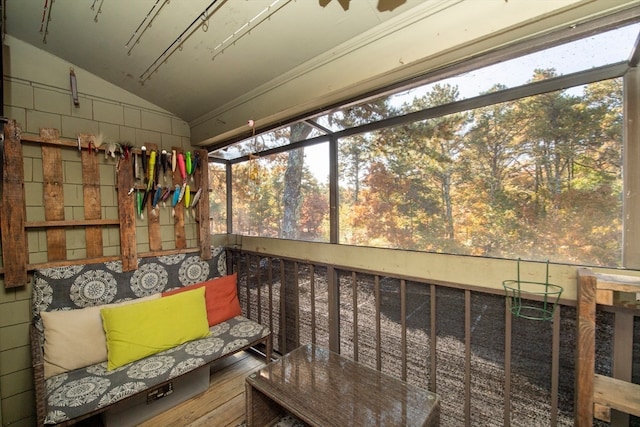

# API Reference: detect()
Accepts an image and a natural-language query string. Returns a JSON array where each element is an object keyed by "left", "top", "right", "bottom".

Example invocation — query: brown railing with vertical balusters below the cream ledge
[{"left": 228, "top": 249, "right": 584, "bottom": 426}]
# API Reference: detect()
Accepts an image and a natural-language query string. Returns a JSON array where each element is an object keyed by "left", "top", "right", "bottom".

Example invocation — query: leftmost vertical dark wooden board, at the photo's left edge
[{"left": 0, "top": 120, "right": 29, "bottom": 288}]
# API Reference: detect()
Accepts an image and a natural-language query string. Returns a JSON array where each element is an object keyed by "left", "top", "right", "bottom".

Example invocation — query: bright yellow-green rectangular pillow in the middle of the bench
[{"left": 100, "top": 288, "right": 209, "bottom": 370}]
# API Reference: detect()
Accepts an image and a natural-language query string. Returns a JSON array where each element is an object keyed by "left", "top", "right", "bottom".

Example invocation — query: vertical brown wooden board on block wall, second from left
[{"left": 40, "top": 128, "right": 67, "bottom": 261}]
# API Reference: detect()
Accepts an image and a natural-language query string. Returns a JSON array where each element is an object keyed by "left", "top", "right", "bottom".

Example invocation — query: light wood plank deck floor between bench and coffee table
[{"left": 79, "top": 351, "right": 264, "bottom": 427}]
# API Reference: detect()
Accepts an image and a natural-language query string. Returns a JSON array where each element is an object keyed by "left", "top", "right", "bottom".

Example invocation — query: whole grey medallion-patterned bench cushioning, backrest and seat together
[{"left": 32, "top": 248, "right": 271, "bottom": 424}]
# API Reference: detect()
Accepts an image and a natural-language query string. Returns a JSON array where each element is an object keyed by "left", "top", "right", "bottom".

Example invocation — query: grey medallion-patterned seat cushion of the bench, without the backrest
[{"left": 45, "top": 316, "right": 270, "bottom": 424}]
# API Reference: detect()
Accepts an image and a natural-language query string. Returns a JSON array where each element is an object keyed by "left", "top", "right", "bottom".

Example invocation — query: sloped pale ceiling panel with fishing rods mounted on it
[{"left": 6, "top": 0, "right": 421, "bottom": 135}]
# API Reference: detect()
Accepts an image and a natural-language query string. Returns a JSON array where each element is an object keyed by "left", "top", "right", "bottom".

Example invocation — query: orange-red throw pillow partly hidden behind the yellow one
[{"left": 162, "top": 273, "right": 242, "bottom": 326}]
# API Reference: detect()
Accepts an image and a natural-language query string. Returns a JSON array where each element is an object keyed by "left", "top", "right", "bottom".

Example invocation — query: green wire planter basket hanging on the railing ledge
[{"left": 502, "top": 259, "right": 563, "bottom": 320}]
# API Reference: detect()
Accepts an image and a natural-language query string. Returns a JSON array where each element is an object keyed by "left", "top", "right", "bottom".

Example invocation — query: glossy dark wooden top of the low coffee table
[{"left": 247, "top": 344, "right": 440, "bottom": 427}]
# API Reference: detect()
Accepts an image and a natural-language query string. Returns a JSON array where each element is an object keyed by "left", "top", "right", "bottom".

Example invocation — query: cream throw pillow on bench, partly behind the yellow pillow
[{"left": 40, "top": 293, "right": 161, "bottom": 379}]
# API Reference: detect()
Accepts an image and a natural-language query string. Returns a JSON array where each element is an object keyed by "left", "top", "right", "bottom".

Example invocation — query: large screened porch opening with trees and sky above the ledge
[{"left": 212, "top": 23, "right": 640, "bottom": 267}]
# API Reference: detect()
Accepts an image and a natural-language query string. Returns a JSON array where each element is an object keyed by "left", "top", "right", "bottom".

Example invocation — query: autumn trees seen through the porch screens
[{"left": 211, "top": 70, "right": 623, "bottom": 267}]
